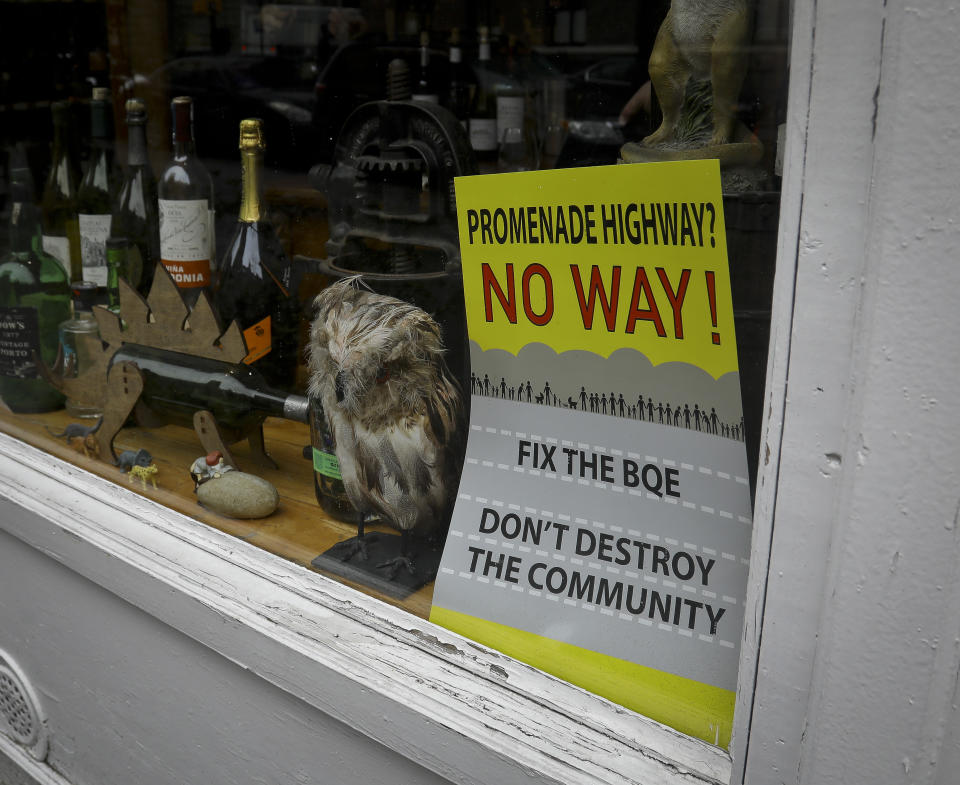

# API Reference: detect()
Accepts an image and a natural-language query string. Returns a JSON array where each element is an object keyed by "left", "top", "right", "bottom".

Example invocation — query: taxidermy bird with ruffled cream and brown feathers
[{"left": 308, "top": 277, "right": 466, "bottom": 579}]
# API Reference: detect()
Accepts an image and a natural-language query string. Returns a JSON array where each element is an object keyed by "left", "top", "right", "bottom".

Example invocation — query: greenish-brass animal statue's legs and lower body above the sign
[{"left": 643, "top": 0, "right": 752, "bottom": 147}]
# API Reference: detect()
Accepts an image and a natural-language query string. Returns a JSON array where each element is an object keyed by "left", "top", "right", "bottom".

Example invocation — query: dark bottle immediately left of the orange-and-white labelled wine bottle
[{"left": 110, "top": 98, "right": 160, "bottom": 296}]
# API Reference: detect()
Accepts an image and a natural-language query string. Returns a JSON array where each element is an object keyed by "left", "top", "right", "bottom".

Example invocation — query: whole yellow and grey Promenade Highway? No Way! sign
[{"left": 430, "top": 161, "right": 752, "bottom": 747}]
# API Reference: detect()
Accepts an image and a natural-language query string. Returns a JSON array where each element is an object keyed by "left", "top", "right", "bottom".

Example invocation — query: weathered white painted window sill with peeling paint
[{"left": 0, "top": 434, "right": 731, "bottom": 785}]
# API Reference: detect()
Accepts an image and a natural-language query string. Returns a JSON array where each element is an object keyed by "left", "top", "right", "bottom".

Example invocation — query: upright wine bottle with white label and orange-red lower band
[{"left": 157, "top": 96, "right": 214, "bottom": 306}]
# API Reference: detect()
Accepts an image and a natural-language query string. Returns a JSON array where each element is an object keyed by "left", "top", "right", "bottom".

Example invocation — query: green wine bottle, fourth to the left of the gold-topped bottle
[{"left": 41, "top": 101, "right": 81, "bottom": 280}]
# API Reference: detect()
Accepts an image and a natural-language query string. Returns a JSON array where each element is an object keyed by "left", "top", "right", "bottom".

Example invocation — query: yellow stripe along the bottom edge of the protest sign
[{"left": 430, "top": 605, "right": 736, "bottom": 749}]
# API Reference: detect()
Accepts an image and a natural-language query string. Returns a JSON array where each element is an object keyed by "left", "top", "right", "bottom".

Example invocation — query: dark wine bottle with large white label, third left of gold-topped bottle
[{"left": 77, "top": 87, "right": 115, "bottom": 286}]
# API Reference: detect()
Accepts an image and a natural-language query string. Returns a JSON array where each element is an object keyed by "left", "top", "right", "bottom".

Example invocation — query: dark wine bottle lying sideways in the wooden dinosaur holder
[{"left": 110, "top": 343, "right": 309, "bottom": 437}]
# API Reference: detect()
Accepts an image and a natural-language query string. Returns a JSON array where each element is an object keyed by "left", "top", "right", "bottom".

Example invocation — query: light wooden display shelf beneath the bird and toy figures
[{"left": 0, "top": 405, "right": 433, "bottom": 619}]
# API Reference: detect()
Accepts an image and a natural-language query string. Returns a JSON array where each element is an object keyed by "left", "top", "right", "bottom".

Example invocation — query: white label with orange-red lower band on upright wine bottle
[{"left": 158, "top": 199, "right": 213, "bottom": 289}]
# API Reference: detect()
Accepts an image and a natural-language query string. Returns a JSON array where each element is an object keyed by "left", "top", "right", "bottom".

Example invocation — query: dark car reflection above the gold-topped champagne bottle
[{"left": 125, "top": 55, "right": 314, "bottom": 169}]
